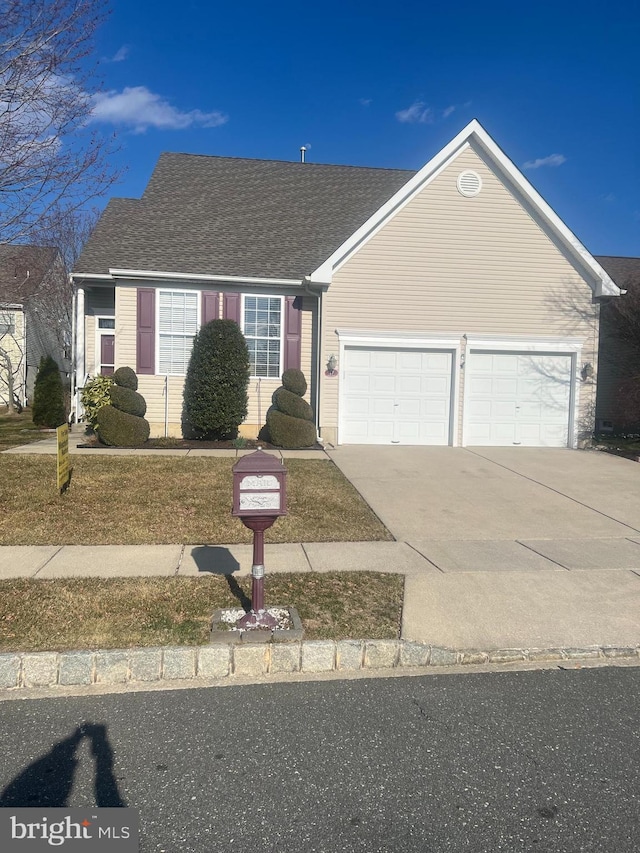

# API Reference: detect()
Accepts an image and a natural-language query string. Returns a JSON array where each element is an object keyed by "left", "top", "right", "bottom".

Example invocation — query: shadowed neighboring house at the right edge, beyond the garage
[{"left": 596, "top": 251, "right": 640, "bottom": 432}]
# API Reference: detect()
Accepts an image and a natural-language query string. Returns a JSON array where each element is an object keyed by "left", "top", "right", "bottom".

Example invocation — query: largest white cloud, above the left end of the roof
[{"left": 91, "top": 86, "right": 229, "bottom": 133}]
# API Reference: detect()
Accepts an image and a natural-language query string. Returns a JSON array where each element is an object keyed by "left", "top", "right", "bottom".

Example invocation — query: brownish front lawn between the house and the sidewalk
[{"left": 0, "top": 454, "right": 392, "bottom": 545}]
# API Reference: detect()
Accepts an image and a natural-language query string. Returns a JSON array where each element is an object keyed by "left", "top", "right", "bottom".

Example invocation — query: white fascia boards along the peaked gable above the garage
[{"left": 309, "top": 119, "right": 620, "bottom": 296}]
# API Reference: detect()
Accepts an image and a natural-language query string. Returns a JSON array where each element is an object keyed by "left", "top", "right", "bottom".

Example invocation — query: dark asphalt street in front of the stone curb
[{"left": 0, "top": 667, "right": 640, "bottom": 853}]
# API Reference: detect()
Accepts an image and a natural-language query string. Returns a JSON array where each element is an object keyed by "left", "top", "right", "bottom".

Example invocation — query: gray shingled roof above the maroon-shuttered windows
[{"left": 74, "top": 154, "right": 415, "bottom": 279}]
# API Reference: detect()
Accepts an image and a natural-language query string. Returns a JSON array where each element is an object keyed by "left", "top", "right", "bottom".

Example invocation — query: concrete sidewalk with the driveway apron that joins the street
[{"left": 0, "top": 539, "right": 640, "bottom": 650}]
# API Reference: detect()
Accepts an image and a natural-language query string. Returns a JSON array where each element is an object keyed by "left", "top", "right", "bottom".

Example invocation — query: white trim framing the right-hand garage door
[{"left": 462, "top": 335, "right": 584, "bottom": 450}]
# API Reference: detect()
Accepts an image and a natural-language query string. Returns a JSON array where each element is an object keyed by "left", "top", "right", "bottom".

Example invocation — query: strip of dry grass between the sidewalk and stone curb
[{"left": 0, "top": 572, "right": 404, "bottom": 652}]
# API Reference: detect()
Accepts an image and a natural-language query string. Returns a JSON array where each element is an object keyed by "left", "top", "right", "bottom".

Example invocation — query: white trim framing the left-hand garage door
[{"left": 334, "top": 329, "right": 462, "bottom": 447}]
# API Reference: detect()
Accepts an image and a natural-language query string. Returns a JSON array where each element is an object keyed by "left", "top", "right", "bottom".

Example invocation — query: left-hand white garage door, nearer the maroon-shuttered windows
[{"left": 340, "top": 347, "right": 452, "bottom": 444}]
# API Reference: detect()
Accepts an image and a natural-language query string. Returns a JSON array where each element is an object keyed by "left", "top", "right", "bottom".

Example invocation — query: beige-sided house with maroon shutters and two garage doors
[{"left": 73, "top": 120, "right": 619, "bottom": 447}]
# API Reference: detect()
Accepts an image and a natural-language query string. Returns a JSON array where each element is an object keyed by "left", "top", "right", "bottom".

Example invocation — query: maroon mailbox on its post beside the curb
[{"left": 231, "top": 449, "right": 287, "bottom": 628}]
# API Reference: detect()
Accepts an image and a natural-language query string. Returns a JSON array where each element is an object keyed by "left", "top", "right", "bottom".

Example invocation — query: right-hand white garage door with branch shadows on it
[{"left": 465, "top": 352, "right": 572, "bottom": 447}]
